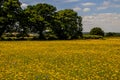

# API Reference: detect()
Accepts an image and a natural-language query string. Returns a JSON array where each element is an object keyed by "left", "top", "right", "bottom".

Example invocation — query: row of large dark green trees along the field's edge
[{"left": 0, "top": 0, "right": 83, "bottom": 40}]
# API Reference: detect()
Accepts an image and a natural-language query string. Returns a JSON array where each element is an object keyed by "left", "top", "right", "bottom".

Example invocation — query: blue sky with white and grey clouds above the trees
[{"left": 20, "top": 0, "right": 120, "bottom": 32}]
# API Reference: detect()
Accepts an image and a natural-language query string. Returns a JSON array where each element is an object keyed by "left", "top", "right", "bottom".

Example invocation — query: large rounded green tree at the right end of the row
[{"left": 52, "top": 9, "right": 82, "bottom": 39}]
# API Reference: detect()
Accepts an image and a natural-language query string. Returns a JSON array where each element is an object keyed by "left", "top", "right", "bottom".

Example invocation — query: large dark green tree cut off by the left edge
[{"left": 0, "top": 0, "right": 21, "bottom": 37}]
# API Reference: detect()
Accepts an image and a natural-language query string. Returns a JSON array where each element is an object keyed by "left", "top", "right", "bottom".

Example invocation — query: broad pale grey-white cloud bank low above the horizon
[{"left": 82, "top": 13, "right": 120, "bottom": 32}]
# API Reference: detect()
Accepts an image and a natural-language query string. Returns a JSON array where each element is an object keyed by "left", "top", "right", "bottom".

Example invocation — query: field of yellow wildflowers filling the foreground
[{"left": 0, "top": 38, "right": 120, "bottom": 80}]
